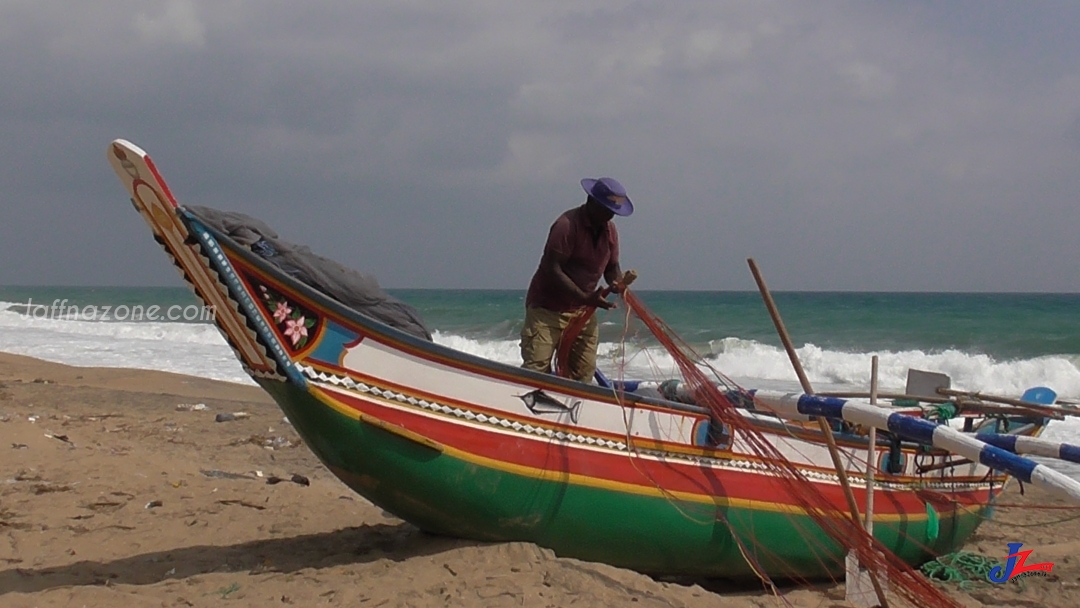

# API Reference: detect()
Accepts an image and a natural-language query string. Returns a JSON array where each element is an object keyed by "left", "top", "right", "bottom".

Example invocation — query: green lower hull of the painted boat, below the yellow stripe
[{"left": 259, "top": 380, "right": 981, "bottom": 579}]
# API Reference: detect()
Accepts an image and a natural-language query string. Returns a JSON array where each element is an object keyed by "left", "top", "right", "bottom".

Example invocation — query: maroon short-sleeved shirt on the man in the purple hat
[{"left": 525, "top": 205, "right": 619, "bottom": 312}]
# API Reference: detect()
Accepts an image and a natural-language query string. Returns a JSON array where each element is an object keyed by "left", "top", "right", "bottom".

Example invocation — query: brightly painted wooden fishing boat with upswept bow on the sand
[{"left": 108, "top": 139, "right": 1080, "bottom": 604}]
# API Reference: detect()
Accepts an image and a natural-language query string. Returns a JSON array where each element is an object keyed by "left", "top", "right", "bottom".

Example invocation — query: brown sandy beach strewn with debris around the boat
[{"left": 0, "top": 354, "right": 1080, "bottom": 608}]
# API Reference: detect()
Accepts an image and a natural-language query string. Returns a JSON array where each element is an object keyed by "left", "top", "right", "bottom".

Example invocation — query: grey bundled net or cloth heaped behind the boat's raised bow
[{"left": 185, "top": 205, "right": 431, "bottom": 340}]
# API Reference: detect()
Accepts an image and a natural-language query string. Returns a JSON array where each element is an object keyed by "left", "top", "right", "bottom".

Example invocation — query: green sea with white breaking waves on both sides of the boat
[{"left": 0, "top": 287, "right": 1080, "bottom": 400}]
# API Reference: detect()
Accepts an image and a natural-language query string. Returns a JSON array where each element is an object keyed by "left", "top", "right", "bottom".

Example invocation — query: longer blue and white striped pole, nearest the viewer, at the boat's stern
[{"left": 754, "top": 391, "right": 1080, "bottom": 502}]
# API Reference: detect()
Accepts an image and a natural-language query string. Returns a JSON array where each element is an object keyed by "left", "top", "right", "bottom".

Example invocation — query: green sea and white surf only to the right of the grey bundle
[{"left": 395, "top": 289, "right": 1080, "bottom": 398}]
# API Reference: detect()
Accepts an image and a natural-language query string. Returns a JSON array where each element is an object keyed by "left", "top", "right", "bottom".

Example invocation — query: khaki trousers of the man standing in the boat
[{"left": 522, "top": 308, "right": 599, "bottom": 383}]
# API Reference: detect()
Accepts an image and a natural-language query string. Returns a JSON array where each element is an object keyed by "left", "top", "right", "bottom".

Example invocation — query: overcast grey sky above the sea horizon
[{"left": 0, "top": 0, "right": 1080, "bottom": 292}]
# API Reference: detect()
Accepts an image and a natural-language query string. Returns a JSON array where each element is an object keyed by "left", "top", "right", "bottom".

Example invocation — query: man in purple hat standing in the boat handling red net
[{"left": 521, "top": 177, "right": 634, "bottom": 382}]
